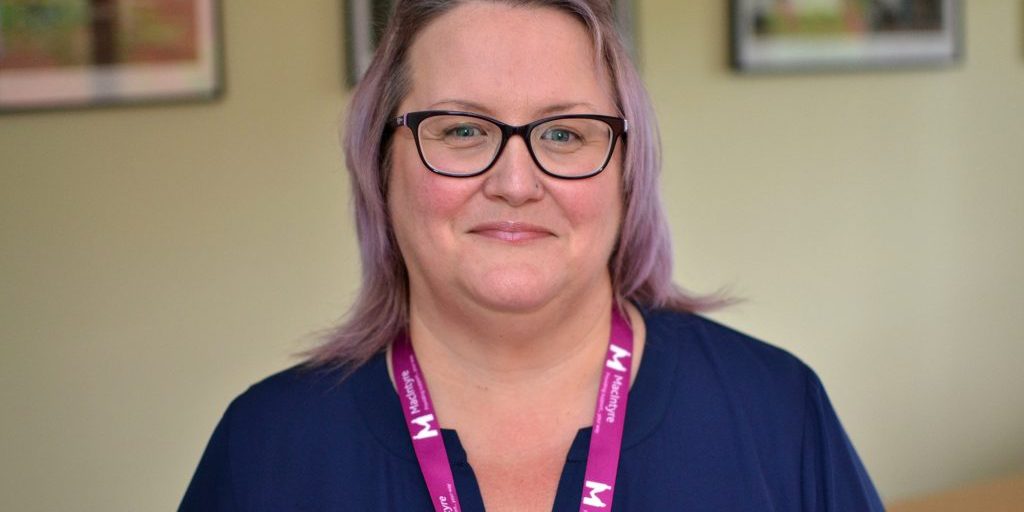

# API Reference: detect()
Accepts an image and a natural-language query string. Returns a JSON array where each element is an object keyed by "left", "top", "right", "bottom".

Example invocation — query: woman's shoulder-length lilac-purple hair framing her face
[{"left": 301, "top": 0, "right": 724, "bottom": 371}]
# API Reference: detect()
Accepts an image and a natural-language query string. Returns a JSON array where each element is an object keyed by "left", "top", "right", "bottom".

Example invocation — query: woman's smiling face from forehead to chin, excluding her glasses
[{"left": 388, "top": 2, "right": 623, "bottom": 312}]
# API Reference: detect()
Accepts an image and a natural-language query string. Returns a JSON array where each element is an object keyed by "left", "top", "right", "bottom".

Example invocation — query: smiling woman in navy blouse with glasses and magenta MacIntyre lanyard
[{"left": 181, "top": 0, "right": 882, "bottom": 512}]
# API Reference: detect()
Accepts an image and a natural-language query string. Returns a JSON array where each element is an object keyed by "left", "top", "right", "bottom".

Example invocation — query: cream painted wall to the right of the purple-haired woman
[{"left": 641, "top": 0, "right": 1024, "bottom": 498}]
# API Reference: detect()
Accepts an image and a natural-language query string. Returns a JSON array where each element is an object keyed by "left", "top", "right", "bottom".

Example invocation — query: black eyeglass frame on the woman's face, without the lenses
[{"left": 388, "top": 111, "right": 629, "bottom": 179}]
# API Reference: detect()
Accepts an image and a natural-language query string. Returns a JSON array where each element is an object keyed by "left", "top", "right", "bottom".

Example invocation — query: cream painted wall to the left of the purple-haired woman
[{"left": 0, "top": 0, "right": 358, "bottom": 512}]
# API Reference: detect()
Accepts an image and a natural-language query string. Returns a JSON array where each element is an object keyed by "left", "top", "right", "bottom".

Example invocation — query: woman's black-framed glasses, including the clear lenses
[{"left": 389, "top": 111, "right": 629, "bottom": 179}]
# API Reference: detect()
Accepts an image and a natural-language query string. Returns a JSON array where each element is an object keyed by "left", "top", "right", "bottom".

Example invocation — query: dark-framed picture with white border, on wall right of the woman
[{"left": 730, "top": 0, "right": 963, "bottom": 72}]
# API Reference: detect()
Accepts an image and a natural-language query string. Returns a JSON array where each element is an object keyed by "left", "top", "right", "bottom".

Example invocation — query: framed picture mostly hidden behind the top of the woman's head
[{"left": 343, "top": 0, "right": 637, "bottom": 87}]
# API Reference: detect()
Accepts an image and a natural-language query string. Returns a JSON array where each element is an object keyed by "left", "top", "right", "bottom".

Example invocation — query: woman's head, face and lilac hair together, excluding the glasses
[{"left": 307, "top": 0, "right": 706, "bottom": 366}]
